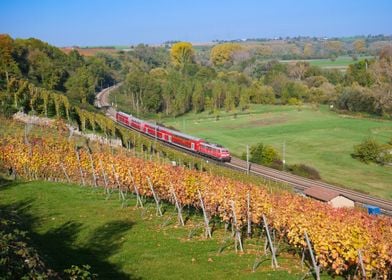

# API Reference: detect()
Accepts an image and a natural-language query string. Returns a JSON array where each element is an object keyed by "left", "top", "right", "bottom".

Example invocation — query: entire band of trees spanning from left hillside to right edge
[{"left": 0, "top": 35, "right": 392, "bottom": 117}]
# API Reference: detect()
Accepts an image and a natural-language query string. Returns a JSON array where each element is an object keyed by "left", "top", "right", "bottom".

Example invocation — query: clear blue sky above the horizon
[{"left": 0, "top": 0, "right": 392, "bottom": 47}]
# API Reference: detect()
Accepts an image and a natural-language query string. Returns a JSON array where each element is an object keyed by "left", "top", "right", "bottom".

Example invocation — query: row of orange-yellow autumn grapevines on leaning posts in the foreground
[{"left": 0, "top": 136, "right": 392, "bottom": 279}]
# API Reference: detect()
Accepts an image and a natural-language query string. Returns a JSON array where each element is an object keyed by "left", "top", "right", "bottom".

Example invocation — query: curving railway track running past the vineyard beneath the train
[{"left": 95, "top": 84, "right": 392, "bottom": 216}]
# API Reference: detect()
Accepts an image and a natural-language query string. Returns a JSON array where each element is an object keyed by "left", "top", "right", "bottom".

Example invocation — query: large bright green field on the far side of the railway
[{"left": 164, "top": 105, "right": 392, "bottom": 199}]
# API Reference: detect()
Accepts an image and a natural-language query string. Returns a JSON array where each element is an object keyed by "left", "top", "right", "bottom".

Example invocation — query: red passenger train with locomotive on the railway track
[{"left": 116, "top": 112, "right": 231, "bottom": 162}]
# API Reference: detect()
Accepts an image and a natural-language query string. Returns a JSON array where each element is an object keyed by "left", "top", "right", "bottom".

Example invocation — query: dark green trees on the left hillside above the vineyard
[{"left": 0, "top": 34, "right": 120, "bottom": 104}]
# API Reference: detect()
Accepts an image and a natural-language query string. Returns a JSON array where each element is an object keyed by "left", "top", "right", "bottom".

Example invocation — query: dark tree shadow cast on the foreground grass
[{"left": 0, "top": 200, "right": 140, "bottom": 280}]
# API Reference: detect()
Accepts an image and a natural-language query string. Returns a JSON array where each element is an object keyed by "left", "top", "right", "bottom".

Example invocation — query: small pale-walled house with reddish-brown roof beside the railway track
[{"left": 304, "top": 187, "right": 354, "bottom": 208}]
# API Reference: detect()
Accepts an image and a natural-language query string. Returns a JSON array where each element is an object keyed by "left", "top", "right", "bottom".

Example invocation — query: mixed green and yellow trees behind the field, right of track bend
[{"left": 112, "top": 42, "right": 392, "bottom": 117}]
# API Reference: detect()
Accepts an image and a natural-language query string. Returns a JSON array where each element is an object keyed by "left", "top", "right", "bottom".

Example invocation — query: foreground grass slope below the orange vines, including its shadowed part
[{"left": 0, "top": 182, "right": 322, "bottom": 279}]
